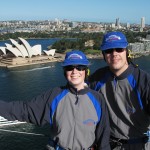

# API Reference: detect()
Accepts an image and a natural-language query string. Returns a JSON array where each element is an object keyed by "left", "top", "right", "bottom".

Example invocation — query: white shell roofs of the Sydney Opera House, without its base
[{"left": 0, "top": 37, "right": 56, "bottom": 58}]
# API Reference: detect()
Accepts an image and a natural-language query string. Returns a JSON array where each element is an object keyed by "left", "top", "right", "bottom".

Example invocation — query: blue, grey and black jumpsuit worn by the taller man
[{"left": 89, "top": 65, "right": 150, "bottom": 150}]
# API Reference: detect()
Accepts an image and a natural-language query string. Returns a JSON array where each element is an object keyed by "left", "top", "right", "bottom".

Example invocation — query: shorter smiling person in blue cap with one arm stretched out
[{"left": 0, "top": 50, "right": 110, "bottom": 150}]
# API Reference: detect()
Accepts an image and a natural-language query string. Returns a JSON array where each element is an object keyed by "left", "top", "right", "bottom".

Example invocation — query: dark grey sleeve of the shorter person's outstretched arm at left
[{"left": 0, "top": 90, "right": 52, "bottom": 125}]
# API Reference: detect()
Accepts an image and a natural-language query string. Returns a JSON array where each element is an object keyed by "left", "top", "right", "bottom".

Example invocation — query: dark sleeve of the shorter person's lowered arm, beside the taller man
[{"left": 96, "top": 94, "right": 110, "bottom": 150}]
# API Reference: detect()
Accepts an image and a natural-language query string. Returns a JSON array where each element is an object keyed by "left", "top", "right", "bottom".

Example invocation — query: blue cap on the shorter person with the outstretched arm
[{"left": 61, "top": 50, "right": 90, "bottom": 67}]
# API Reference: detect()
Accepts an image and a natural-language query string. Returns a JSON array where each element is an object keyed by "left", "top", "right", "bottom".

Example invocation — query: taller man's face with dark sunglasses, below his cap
[{"left": 104, "top": 48, "right": 128, "bottom": 76}]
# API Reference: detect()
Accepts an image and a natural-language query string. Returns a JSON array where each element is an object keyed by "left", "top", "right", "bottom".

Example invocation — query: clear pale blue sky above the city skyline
[{"left": 0, "top": 0, "right": 150, "bottom": 24}]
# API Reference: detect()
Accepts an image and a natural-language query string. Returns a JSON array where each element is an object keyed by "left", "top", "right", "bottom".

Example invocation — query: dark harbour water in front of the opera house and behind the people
[{"left": 0, "top": 41, "right": 150, "bottom": 150}]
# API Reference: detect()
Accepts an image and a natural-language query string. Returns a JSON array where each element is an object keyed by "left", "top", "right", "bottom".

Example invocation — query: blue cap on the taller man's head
[{"left": 100, "top": 31, "right": 128, "bottom": 51}]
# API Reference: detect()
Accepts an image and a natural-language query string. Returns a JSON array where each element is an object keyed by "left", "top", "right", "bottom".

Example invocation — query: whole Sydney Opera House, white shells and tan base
[{"left": 0, "top": 37, "right": 56, "bottom": 66}]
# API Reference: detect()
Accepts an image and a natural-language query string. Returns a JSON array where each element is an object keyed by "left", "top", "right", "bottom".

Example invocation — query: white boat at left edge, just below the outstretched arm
[{"left": 0, "top": 116, "right": 25, "bottom": 127}]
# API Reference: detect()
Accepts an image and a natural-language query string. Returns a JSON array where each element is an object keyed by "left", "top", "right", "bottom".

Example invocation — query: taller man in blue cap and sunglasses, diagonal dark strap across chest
[{"left": 89, "top": 32, "right": 150, "bottom": 150}]
